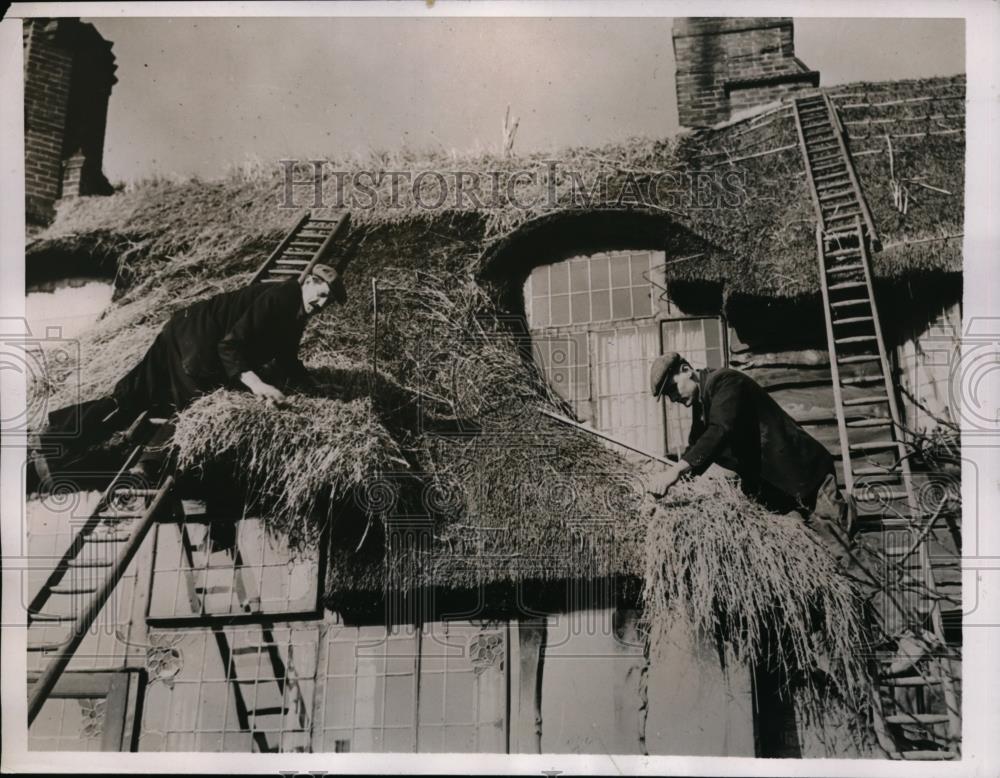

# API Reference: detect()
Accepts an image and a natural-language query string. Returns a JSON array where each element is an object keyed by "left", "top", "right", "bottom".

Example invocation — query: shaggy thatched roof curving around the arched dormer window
[{"left": 27, "top": 77, "right": 964, "bottom": 598}]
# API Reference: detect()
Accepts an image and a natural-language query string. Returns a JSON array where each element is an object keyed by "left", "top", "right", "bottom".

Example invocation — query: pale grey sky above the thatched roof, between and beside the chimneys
[{"left": 86, "top": 18, "right": 965, "bottom": 182}]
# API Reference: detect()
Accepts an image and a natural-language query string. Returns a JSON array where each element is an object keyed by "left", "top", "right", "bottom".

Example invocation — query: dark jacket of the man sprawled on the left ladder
[{"left": 170, "top": 278, "right": 306, "bottom": 384}]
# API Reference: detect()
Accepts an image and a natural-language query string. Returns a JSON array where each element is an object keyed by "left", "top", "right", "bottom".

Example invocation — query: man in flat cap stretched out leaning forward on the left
[{"left": 49, "top": 264, "right": 346, "bottom": 464}]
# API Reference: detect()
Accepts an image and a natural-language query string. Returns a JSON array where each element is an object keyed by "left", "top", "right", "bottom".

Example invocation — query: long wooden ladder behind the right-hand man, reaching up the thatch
[{"left": 794, "top": 94, "right": 961, "bottom": 759}]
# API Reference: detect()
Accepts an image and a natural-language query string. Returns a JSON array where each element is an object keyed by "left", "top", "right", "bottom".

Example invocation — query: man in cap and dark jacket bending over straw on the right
[{"left": 647, "top": 353, "right": 928, "bottom": 674}]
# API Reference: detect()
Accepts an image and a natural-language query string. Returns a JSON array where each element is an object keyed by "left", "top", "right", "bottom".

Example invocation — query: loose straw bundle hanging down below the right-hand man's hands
[{"left": 643, "top": 478, "right": 873, "bottom": 736}]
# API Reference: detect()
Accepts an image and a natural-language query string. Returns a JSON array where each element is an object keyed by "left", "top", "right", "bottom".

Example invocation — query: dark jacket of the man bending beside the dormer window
[{"left": 683, "top": 368, "right": 833, "bottom": 510}]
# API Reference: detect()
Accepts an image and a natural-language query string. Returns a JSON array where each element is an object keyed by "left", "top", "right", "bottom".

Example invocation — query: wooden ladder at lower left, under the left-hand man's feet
[{"left": 27, "top": 415, "right": 174, "bottom": 726}]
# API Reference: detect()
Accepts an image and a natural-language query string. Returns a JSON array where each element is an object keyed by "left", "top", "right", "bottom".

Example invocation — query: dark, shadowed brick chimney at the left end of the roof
[{"left": 24, "top": 19, "right": 118, "bottom": 225}]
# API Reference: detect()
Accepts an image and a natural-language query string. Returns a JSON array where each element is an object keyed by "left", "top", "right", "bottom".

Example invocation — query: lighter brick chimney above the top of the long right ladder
[{"left": 673, "top": 17, "right": 819, "bottom": 127}]
